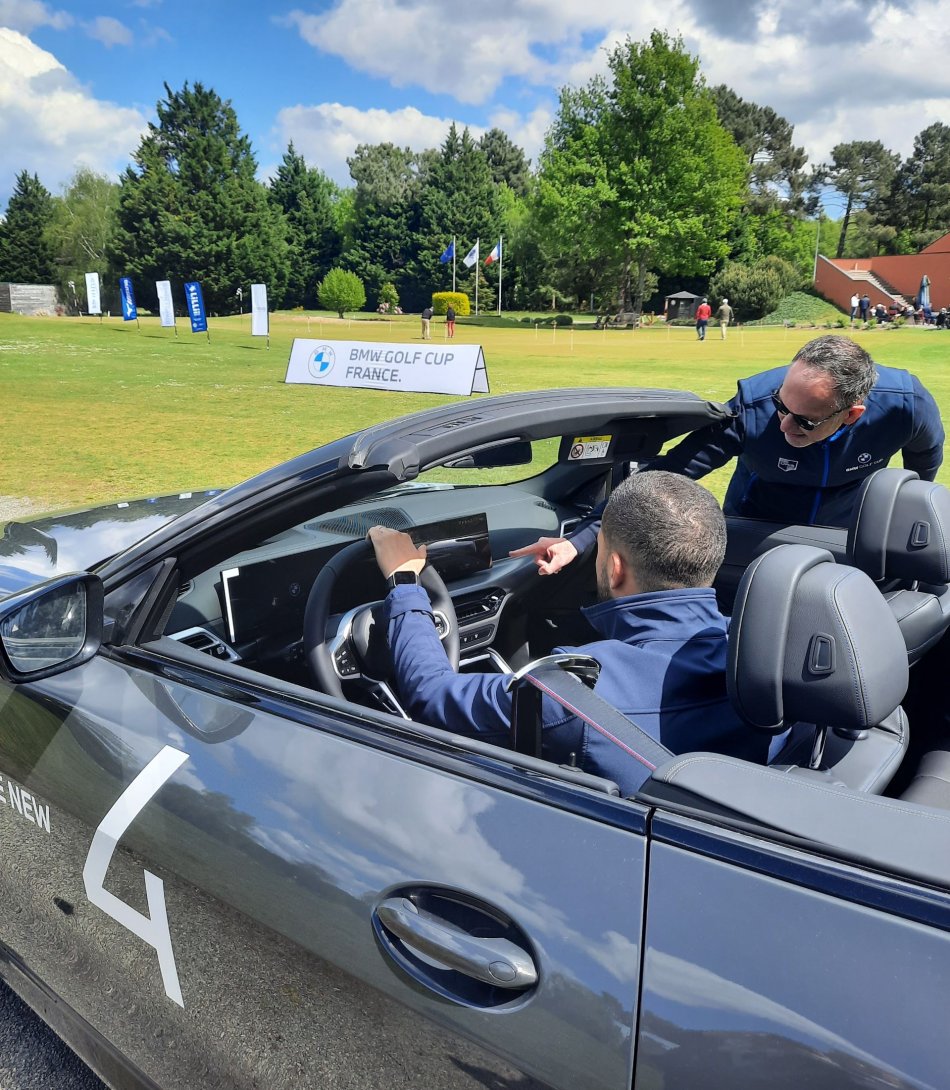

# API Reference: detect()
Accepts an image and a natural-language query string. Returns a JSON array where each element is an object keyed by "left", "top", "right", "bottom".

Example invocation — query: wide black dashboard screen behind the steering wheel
[{"left": 220, "top": 512, "right": 491, "bottom": 644}]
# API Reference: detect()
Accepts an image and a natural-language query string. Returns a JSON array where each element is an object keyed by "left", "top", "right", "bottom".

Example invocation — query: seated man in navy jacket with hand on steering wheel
[{"left": 369, "top": 472, "right": 769, "bottom": 795}]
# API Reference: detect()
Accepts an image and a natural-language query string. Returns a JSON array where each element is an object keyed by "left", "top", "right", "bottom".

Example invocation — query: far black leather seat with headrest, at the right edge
[{"left": 847, "top": 469, "right": 950, "bottom": 663}]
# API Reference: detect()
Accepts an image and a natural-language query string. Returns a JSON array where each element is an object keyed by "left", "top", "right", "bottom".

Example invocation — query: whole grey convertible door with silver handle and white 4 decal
[{"left": 0, "top": 640, "right": 646, "bottom": 1090}]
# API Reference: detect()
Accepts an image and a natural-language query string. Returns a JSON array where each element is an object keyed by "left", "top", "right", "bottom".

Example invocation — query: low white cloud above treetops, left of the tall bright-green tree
[{"left": 275, "top": 102, "right": 483, "bottom": 185}]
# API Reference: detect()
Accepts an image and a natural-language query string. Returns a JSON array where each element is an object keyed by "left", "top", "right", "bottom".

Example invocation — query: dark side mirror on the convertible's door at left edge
[{"left": 0, "top": 572, "right": 103, "bottom": 685}]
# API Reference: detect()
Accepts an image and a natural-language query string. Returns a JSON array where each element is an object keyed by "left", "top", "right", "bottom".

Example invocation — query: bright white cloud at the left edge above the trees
[{"left": 0, "top": 27, "right": 146, "bottom": 206}]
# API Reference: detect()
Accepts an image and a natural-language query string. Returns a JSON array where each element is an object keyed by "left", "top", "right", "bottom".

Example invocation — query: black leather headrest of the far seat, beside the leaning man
[{"left": 848, "top": 469, "right": 950, "bottom": 586}]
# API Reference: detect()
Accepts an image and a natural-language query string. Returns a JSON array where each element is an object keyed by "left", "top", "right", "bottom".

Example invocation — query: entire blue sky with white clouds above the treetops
[{"left": 0, "top": 0, "right": 950, "bottom": 214}]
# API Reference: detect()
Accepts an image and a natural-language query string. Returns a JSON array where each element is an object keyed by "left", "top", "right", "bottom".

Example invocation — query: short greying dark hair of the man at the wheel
[{"left": 600, "top": 470, "right": 726, "bottom": 591}]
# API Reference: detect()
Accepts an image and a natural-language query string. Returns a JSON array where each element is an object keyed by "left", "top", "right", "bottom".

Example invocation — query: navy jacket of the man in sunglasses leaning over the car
[{"left": 571, "top": 365, "right": 943, "bottom": 552}]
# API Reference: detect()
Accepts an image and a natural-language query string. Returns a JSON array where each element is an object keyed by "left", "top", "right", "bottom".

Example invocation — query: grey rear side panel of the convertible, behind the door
[{"left": 634, "top": 806, "right": 950, "bottom": 1090}]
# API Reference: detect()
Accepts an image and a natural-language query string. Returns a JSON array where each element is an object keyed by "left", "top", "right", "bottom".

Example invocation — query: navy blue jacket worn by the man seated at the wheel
[{"left": 387, "top": 585, "right": 770, "bottom": 795}]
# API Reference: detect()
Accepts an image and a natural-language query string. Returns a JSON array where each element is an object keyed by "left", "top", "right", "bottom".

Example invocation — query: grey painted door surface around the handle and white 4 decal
[{"left": 0, "top": 645, "right": 645, "bottom": 1090}]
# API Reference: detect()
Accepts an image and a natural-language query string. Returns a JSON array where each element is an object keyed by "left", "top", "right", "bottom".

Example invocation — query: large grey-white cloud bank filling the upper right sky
[{"left": 281, "top": 0, "right": 950, "bottom": 176}]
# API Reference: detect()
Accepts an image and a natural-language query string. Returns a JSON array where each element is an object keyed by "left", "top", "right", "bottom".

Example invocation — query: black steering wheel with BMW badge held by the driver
[{"left": 303, "top": 540, "right": 459, "bottom": 697}]
